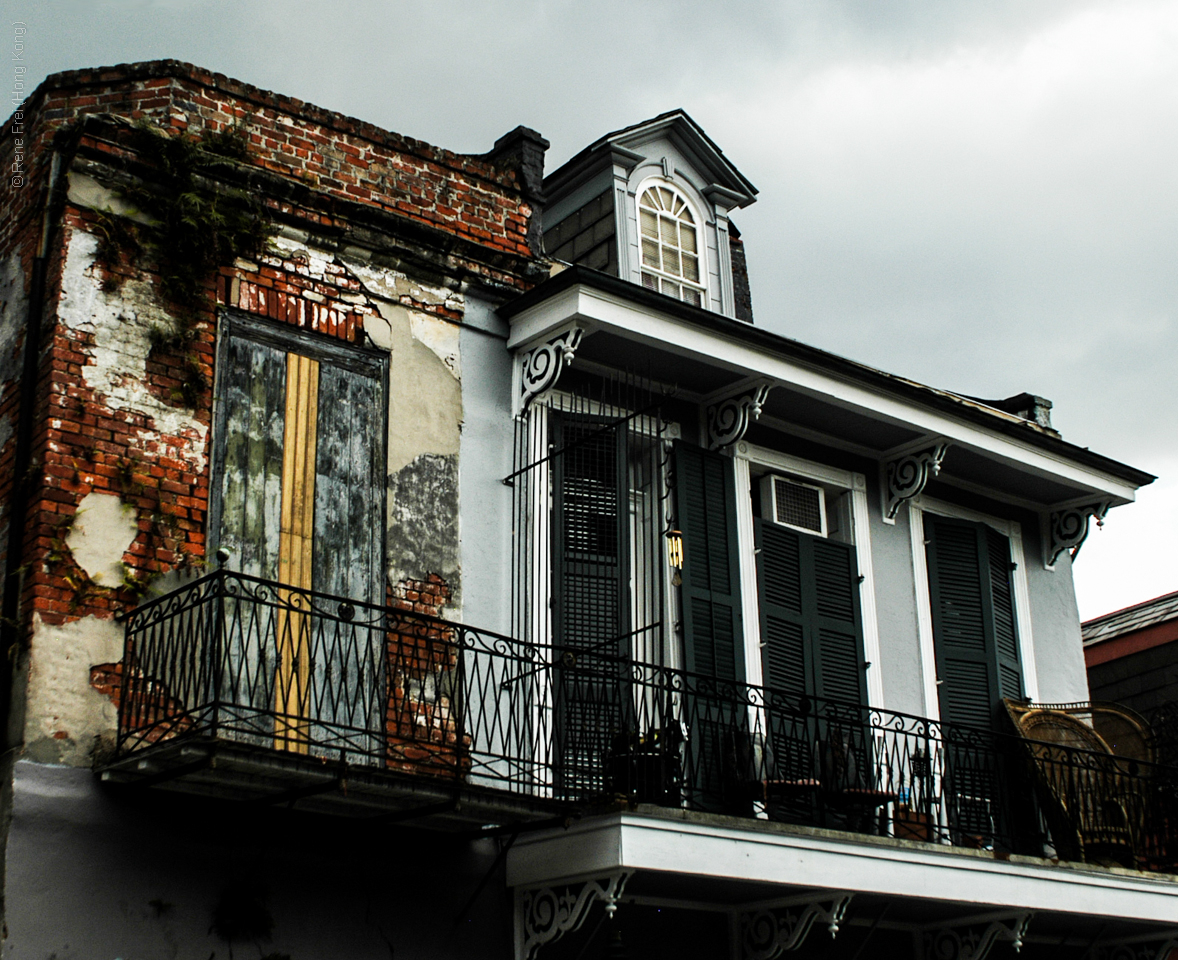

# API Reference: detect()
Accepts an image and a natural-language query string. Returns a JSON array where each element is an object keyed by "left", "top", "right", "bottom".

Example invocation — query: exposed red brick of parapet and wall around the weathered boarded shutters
[{"left": 0, "top": 61, "right": 534, "bottom": 636}]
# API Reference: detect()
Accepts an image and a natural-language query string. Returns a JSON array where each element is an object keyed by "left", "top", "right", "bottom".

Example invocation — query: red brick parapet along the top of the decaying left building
[{"left": 0, "top": 60, "right": 534, "bottom": 270}]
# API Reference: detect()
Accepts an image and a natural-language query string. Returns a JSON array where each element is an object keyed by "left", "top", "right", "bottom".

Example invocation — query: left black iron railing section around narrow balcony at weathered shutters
[{"left": 115, "top": 570, "right": 551, "bottom": 795}]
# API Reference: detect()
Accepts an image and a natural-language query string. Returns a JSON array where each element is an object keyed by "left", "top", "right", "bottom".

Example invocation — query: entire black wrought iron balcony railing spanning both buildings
[{"left": 117, "top": 571, "right": 1178, "bottom": 868}]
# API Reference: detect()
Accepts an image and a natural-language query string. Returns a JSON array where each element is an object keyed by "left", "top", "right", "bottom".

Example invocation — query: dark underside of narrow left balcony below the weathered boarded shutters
[{"left": 101, "top": 737, "right": 567, "bottom": 830}]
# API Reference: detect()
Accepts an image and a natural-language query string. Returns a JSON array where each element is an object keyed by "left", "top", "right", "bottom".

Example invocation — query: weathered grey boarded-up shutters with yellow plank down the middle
[{"left": 210, "top": 312, "right": 388, "bottom": 750}]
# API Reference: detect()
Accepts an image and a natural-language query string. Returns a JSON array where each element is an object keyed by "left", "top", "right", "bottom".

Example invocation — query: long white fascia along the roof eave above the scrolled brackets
[{"left": 508, "top": 285, "right": 1137, "bottom": 503}]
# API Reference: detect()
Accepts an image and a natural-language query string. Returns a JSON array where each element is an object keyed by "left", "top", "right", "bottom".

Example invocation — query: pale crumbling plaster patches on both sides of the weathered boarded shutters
[{"left": 26, "top": 219, "right": 473, "bottom": 764}]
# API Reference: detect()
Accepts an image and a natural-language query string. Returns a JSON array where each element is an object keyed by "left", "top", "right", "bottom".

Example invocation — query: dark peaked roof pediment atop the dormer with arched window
[{"left": 544, "top": 110, "right": 757, "bottom": 210}]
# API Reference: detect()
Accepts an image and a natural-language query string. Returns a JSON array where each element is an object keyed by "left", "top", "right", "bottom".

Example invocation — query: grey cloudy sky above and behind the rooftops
[{"left": 20, "top": 0, "right": 1178, "bottom": 617}]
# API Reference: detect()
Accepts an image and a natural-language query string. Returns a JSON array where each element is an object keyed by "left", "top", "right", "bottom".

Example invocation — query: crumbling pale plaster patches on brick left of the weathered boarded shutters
[{"left": 25, "top": 221, "right": 209, "bottom": 766}]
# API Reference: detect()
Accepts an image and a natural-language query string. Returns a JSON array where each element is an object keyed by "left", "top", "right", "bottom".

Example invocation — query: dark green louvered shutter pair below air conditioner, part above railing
[{"left": 756, "top": 519, "right": 866, "bottom": 703}]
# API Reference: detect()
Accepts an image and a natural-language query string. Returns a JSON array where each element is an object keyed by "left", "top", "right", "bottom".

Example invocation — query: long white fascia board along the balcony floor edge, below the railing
[{"left": 507, "top": 812, "right": 1178, "bottom": 923}]
